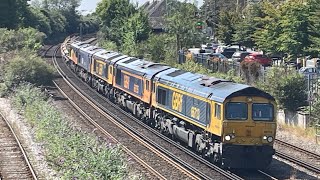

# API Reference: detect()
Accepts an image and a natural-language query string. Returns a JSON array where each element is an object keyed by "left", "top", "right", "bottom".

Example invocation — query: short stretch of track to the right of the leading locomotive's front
[{"left": 275, "top": 139, "right": 320, "bottom": 174}]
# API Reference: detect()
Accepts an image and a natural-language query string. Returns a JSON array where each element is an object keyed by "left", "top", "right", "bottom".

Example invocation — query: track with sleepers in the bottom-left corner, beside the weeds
[{"left": 0, "top": 113, "right": 37, "bottom": 180}]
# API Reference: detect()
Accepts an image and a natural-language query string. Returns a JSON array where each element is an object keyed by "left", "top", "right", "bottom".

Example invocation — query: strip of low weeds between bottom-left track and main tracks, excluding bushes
[{"left": 12, "top": 84, "right": 131, "bottom": 179}]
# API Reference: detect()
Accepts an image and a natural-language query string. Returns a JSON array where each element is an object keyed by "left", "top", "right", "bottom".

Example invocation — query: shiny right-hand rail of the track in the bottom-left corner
[{"left": 0, "top": 112, "right": 38, "bottom": 180}]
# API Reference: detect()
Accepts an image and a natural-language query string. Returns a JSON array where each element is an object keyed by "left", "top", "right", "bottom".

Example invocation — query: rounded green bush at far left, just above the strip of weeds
[{"left": 3, "top": 51, "right": 54, "bottom": 87}]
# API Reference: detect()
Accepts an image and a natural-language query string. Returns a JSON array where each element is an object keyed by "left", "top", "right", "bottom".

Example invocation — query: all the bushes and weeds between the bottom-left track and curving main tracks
[{"left": 0, "top": 17, "right": 134, "bottom": 179}]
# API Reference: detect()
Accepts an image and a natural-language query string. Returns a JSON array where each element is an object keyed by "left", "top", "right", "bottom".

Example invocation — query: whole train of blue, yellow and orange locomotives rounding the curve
[{"left": 61, "top": 39, "right": 277, "bottom": 169}]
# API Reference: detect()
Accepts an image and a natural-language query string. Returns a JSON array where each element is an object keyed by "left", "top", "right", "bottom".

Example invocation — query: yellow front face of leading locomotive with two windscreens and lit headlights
[{"left": 221, "top": 96, "right": 276, "bottom": 169}]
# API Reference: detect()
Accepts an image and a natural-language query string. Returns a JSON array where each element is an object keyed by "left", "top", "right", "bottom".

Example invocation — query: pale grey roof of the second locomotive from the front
[{"left": 117, "top": 57, "right": 171, "bottom": 79}]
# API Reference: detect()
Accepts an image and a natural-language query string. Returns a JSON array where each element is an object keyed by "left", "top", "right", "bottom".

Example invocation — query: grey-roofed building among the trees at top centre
[{"left": 141, "top": 0, "right": 166, "bottom": 33}]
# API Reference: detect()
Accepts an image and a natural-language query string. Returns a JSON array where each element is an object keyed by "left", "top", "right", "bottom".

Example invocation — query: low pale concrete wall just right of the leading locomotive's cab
[{"left": 277, "top": 110, "right": 309, "bottom": 129}]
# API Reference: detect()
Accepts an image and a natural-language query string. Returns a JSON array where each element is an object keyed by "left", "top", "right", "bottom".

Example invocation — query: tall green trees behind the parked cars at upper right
[{"left": 201, "top": 0, "right": 320, "bottom": 60}]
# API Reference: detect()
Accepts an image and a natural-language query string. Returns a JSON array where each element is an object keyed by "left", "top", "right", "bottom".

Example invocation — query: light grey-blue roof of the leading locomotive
[{"left": 156, "top": 68, "right": 274, "bottom": 103}]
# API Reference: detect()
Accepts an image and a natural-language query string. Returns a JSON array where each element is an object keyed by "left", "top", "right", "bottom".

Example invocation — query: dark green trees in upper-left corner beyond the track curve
[{"left": 0, "top": 0, "right": 99, "bottom": 41}]
